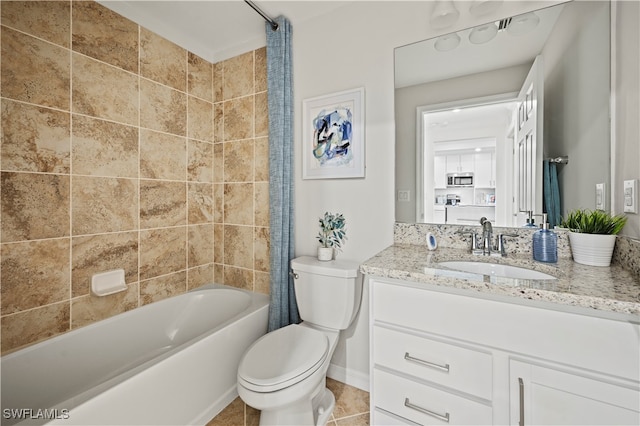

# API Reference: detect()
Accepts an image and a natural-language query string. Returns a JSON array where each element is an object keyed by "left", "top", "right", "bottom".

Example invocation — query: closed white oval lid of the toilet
[{"left": 238, "top": 324, "right": 329, "bottom": 392}]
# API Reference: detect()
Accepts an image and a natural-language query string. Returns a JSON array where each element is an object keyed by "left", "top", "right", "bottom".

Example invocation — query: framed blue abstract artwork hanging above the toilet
[{"left": 302, "top": 87, "right": 365, "bottom": 179}]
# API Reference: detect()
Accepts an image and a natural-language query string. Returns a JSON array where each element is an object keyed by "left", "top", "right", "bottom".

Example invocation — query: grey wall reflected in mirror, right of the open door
[{"left": 542, "top": 1, "right": 611, "bottom": 216}]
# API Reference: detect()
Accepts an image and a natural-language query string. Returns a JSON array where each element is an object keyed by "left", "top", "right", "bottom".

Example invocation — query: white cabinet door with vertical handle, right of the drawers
[{"left": 509, "top": 360, "right": 640, "bottom": 426}]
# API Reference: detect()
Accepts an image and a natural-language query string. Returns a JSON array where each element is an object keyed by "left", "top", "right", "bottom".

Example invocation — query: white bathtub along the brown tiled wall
[{"left": 0, "top": 284, "right": 269, "bottom": 426}]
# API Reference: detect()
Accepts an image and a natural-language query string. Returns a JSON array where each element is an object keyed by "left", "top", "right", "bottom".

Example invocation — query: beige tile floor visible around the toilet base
[{"left": 207, "top": 378, "right": 369, "bottom": 426}]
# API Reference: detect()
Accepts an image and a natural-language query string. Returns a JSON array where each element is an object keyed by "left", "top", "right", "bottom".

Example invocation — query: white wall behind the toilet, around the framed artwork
[{"left": 293, "top": 1, "right": 558, "bottom": 389}]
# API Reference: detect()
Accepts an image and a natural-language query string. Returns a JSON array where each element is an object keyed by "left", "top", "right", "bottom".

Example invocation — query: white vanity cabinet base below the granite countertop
[{"left": 368, "top": 277, "right": 640, "bottom": 425}]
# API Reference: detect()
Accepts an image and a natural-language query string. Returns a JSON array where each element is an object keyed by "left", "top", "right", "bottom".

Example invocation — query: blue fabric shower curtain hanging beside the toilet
[{"left": 265, "top": 16, "right": 300, "bottom": 331}]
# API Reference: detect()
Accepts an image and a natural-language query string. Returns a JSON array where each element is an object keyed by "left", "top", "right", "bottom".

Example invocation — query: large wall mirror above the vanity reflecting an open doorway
[{"left": 394, "top": 1, "right": 611, "bottom": 226}]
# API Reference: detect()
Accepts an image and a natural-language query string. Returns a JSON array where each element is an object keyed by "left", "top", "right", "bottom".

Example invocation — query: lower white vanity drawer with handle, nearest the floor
[{"left": 373, "top": 368, "right": 493, "bottom": 425}]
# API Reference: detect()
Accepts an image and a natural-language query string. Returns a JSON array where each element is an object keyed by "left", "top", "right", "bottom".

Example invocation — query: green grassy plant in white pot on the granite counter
[{"left": 560, "top": 209, "right": 627, "bottom": 266}]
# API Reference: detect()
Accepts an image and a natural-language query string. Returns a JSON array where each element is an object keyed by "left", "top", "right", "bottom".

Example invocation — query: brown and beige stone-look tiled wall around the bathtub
[{"left": 0, "top": 1, "right": 269, "bottom": 353}]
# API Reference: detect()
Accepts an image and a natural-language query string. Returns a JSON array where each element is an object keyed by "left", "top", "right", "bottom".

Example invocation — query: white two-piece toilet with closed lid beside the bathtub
[{"left": 238, "top": 256, "right": 362, "bottom": 425}]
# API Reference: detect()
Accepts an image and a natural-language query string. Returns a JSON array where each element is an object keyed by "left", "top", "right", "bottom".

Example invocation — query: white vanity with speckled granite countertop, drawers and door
[{"left": 362, "top": 241, "right": 640, "bottom": 425}]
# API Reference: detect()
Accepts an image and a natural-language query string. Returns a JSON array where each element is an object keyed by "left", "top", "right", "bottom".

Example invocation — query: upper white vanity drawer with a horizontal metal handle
[{"left": 372, "top": 326, "right": 493, "bottom": 400}]
